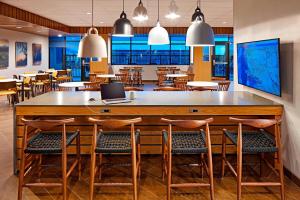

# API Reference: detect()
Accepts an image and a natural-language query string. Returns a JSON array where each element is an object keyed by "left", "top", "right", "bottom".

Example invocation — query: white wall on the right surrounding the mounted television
[{"left": 234, "top": 0, "right": 300, "bottom": 178}]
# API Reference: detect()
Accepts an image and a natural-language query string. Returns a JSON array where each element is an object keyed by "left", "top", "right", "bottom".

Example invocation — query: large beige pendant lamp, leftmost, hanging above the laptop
[{"left": 78, "top": 0, "right": 107, "bottom": 58}]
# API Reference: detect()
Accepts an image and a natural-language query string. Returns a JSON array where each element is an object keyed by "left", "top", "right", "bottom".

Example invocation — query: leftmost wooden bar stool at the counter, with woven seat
[{"left": 18, "top": 118, "right": 81, "bottom": 200}]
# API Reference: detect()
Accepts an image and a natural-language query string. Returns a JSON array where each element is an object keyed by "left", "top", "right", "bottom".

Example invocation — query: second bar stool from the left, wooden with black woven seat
[{"left": 89, "top": 118, "right": 142, "bottom": 200}]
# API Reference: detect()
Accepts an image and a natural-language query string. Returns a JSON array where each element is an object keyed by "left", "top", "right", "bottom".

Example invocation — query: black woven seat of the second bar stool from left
[{"left": 95, "top": 131, "right": 140, "bottom": 153}]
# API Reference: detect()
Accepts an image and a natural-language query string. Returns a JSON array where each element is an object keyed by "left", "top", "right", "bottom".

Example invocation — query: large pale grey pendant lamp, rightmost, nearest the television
[{"left": 186, "top": 0, "right": 215, "bottom": 46}]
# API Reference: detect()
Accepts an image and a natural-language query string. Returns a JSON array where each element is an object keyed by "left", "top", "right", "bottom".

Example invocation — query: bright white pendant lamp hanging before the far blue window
[{"left": 148, "top": 0, "right": 170, "bottom": 45}]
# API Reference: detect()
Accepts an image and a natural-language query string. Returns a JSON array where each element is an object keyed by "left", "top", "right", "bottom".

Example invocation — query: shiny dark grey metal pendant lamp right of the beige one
[{"left": 112, "top": 0, "right": 134, "bottom": 37}]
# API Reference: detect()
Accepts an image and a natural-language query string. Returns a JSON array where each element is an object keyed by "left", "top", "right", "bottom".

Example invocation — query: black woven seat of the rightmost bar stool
[{"left": 225, "top": 129, "right": 278, "bottom": 153}]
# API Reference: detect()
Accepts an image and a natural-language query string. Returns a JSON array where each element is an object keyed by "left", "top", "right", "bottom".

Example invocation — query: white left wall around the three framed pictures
[{"left": 0, "top": 29, "right": 49, "bottom": 78}]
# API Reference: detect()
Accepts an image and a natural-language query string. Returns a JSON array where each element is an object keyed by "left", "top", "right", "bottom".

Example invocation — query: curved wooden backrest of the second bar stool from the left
[{"left": 89, "top": 117, "right": 142, "bottom": 129}]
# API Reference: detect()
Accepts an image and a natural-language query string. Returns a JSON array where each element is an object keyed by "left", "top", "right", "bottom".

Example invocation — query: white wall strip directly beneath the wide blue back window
[{"left": 111, "top": 65, "right": 190, "bottom": 80}]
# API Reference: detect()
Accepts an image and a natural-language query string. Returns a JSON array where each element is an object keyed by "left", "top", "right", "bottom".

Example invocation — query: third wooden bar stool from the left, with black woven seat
[{"left": 161, "top": 118, "right": 214, "bottom": 200}]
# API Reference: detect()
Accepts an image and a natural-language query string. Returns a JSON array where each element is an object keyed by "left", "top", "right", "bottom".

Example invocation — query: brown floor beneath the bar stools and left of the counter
[{"left": 0, "top": 86, "right": 300, "bottom": 200}]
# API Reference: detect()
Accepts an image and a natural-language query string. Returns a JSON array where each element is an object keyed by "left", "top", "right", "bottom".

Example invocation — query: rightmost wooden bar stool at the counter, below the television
[{"left": 221, "top": 117, "right": 285, "bottom": 200}]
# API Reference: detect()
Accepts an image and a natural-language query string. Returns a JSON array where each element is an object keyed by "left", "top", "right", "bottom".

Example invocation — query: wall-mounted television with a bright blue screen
[{"left": 237, "top": 38, "right": 281, "bottom": 96}]
